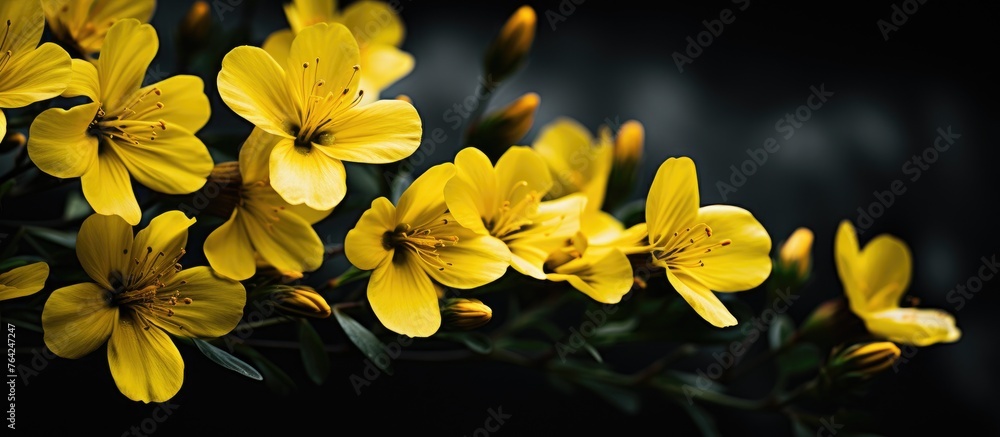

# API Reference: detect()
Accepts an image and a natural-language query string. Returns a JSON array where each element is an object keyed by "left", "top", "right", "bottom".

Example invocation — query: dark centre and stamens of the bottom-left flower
[{"left": 111, "top": 247, "right": 194, "bottom": 330}]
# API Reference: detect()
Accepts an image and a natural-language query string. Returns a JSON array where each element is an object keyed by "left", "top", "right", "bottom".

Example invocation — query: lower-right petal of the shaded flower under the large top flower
[{"left": 242, "top": 204, "right": 324, "bottom": 272}]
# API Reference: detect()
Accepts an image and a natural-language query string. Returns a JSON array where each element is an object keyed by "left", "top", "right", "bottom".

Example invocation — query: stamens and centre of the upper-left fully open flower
[{"left": 87, "top": 87, "right": 167, "bottom": 145}]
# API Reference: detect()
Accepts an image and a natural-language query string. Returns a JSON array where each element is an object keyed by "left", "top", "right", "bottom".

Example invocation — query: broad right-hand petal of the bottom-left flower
[{"left": 150, "top": 266, "right": 247, "bottom": 338}]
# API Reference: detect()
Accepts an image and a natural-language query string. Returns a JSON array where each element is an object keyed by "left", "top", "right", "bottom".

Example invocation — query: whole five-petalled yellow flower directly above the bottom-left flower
[{"left": 28, "top": 19, "right": 212, "bottom": 226}]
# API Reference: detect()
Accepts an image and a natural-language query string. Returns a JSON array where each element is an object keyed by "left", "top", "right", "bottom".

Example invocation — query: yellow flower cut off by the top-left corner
[{"left": 0, "top": 0, "right": 72, "bottom": 138}]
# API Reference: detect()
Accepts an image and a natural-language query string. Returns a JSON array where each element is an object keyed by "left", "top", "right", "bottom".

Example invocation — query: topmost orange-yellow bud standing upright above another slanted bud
[{"left": 484, "top": 5, "right": 538, "bottom": 82}]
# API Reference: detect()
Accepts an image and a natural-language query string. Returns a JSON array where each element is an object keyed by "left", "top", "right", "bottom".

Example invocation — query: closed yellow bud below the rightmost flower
[{"left": 826, "top": 341, "right": 901, "bottom": 384}]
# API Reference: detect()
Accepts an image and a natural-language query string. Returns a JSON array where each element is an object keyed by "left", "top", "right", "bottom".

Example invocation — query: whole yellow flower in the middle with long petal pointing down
[{"left": 344, "top": 163, "right": 510, "bottom": 337}]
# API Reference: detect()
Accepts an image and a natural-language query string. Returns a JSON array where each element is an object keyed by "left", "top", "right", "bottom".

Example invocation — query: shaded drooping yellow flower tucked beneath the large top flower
[{"left": 205, "top": 129, "right": 331, "bottom": 280}]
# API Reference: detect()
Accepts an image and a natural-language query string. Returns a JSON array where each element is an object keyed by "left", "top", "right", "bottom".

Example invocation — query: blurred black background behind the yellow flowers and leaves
[{"left": 7, "top": 0, "right": 1000, "bottom": 435}]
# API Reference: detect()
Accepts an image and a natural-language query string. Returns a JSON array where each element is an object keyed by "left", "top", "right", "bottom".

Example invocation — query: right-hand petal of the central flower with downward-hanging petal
[{"left": 426, "top": 222, "right": 510, "bottom": 290}]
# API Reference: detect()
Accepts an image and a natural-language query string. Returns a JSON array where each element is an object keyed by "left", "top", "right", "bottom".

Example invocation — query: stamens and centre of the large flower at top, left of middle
[{"left": 293, "top": 57, "right": 364, "bottom": 145}]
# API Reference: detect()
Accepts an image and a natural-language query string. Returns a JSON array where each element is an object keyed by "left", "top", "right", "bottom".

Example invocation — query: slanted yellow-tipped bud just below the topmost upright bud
[{"left": 468, "top": 93, "right": 539, "bottom": 150}]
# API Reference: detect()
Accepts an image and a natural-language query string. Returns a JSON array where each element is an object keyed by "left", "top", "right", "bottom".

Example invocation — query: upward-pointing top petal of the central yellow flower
[{"left": 396, "top": 163, "right": 455, "bottom": 228}]
